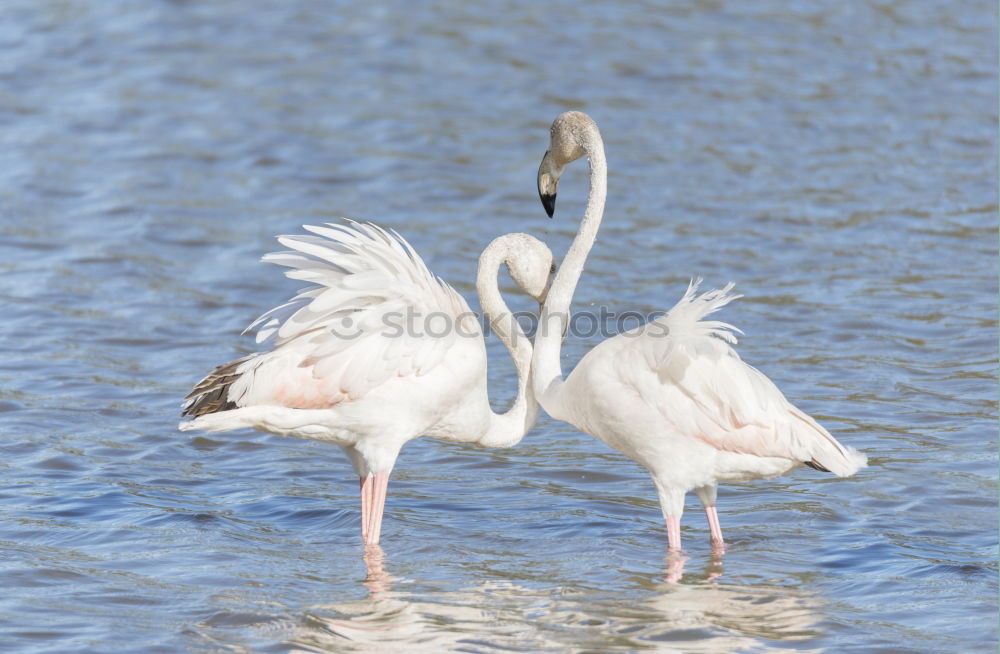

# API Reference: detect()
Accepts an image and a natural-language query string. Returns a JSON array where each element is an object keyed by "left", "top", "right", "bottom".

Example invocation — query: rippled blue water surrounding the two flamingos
[{"left": 0, "top": 0, "right": 997, "bottom": 653}]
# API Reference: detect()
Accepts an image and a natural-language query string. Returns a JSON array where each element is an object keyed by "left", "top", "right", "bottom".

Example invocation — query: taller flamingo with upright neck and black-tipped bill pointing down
[{"left": 532, "top": 112, "right": 866, "bottom": 551}]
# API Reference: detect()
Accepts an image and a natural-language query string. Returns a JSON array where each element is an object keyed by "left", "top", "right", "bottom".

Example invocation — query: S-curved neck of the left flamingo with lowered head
[{"left": 476, "top": 236, "right": 539, "bottom": 447}]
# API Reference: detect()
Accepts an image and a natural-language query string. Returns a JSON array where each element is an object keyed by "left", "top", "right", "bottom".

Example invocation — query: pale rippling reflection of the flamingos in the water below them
[{"left": 285, "top": 560, "right": 823, "bottom": 654}]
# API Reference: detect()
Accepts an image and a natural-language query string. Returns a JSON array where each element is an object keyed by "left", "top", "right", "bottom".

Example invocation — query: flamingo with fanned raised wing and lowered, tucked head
[{"left": 180, "top": 223, "right": 554, "bottom": 544}]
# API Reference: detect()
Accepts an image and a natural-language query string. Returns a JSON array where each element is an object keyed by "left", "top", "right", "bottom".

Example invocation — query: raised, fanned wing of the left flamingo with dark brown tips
[{"left": 186, "top": 222, "right": 481, "bottom": 415}]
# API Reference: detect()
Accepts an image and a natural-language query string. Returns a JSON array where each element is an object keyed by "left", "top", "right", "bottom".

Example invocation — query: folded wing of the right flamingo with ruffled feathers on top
[{"left": 635, "top": 280, "right": 865, "bottom": 476}]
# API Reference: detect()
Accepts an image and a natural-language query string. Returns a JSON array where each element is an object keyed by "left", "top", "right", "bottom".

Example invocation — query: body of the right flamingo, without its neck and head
[{"left": 543, "top": 283, "right": 864, "bottom": 518}]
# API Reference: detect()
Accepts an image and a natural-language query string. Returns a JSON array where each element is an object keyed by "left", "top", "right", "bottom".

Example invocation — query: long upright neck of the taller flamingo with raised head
[{"left": 531, "top": 126, "right": 608, "bottom": 419}]
